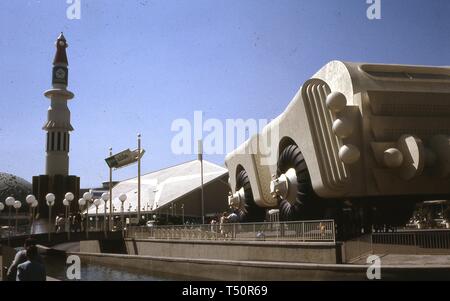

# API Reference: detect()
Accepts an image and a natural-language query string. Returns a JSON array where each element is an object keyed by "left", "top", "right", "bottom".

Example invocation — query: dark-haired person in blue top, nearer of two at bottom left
[{"left": 16, "top": 245, "right": 47, "bottom": 281}]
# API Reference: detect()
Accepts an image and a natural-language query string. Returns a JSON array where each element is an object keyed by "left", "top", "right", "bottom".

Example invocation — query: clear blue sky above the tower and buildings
[{"left": 0, "top": 0, "right": 450, "bottom": 187}]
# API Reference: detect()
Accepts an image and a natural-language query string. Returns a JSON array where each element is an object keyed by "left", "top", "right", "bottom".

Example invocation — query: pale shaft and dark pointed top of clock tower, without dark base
[{"left": 42, "top": 33, "right": 74, "bottom": 176}]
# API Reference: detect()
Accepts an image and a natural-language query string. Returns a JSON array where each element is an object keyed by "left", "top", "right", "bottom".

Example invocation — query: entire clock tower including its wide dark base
[{"left": 33, "top": 33, "right": 80, "bottom": 217}]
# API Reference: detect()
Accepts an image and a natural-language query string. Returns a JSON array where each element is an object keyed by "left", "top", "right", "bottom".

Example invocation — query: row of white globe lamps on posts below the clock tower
[{"left": 0, "top": 192, "right": 132, "bottom": 240}]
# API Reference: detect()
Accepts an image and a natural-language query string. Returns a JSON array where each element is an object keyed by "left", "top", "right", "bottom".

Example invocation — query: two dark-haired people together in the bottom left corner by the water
[{"left": 7, "top": 238, "right": 47, "bottom": 281}]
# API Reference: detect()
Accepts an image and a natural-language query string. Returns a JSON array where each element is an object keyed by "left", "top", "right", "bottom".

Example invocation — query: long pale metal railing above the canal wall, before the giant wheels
[{"left": 125, "top": 220, "right": 336, "bottom": 242}]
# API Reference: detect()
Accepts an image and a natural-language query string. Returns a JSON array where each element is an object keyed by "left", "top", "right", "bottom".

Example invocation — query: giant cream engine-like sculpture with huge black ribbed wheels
[{"left": 225, "top": 61, "right": 450, "bottom": 231}]
